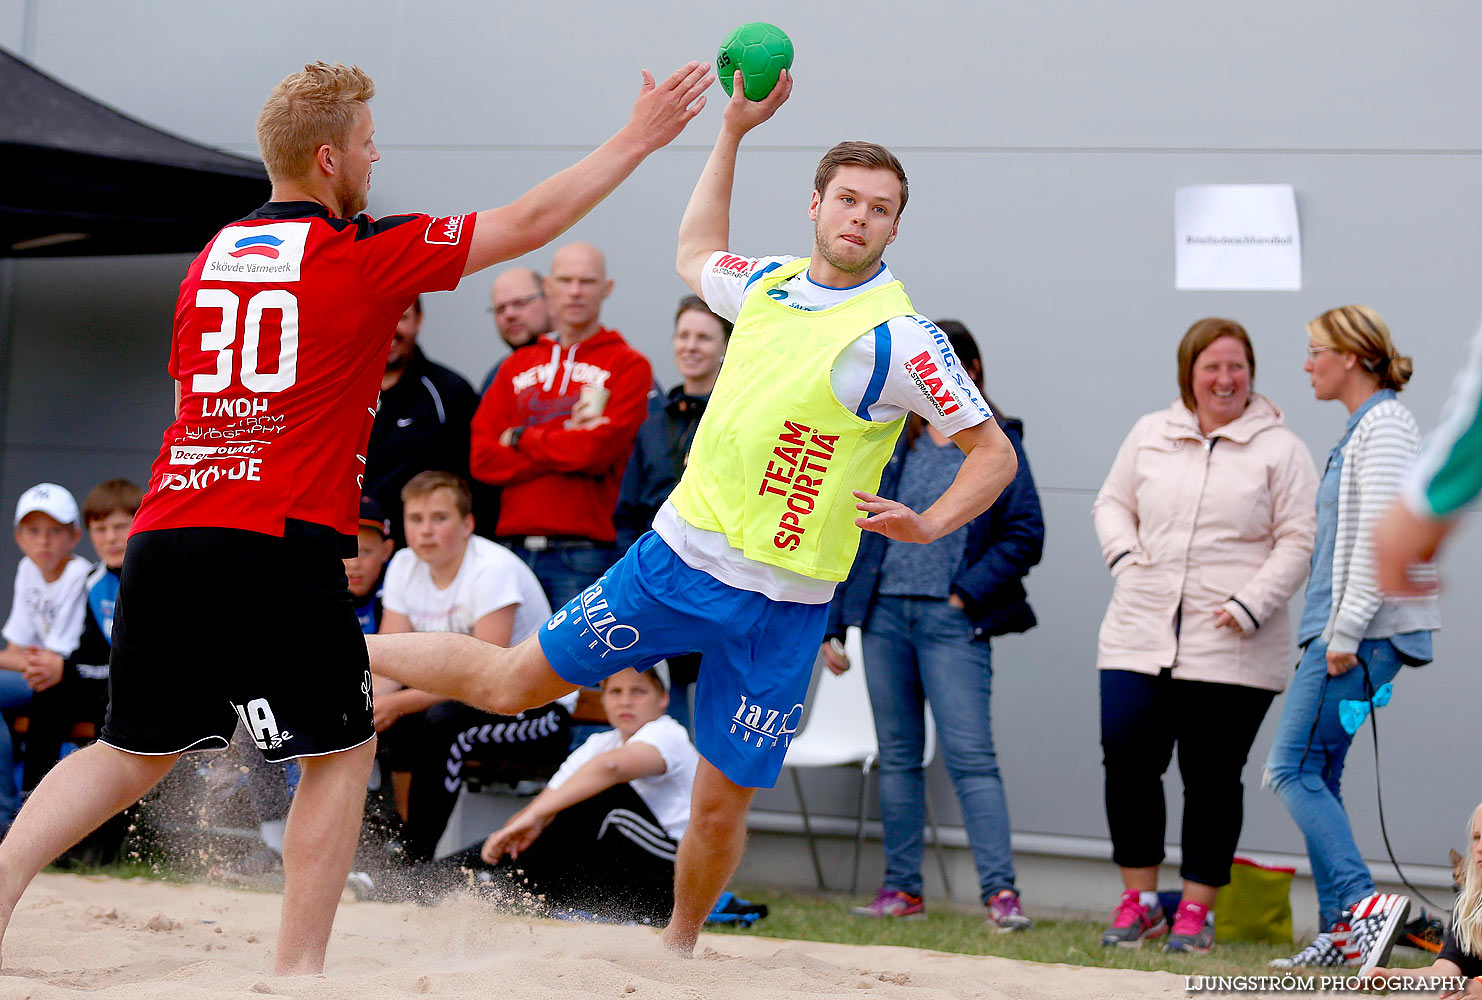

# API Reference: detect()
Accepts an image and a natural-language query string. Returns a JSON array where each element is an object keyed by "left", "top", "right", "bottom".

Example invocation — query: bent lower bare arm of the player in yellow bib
[{"left": 854, "top": 419, "right": 1018, "bottom": 544}]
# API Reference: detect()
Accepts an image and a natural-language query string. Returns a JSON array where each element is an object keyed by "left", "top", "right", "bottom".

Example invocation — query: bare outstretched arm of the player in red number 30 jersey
[{"left": 464, "top": 62, "right": 716, "bottom": 274}]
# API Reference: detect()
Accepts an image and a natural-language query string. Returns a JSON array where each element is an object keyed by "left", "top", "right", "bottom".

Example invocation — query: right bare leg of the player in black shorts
[{"left": 274, "top": 739, "right": 375, "bottom": 976}]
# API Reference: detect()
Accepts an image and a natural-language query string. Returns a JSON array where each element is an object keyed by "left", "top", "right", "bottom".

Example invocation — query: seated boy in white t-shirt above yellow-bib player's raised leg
[{"left": 375, "top": 471, "right": 576, "bottom": 862}]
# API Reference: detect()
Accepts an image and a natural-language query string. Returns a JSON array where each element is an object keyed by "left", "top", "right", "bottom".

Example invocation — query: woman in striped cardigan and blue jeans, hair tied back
[{"left": 1266, "top": 305, "right": 1441, "bottom": 967}]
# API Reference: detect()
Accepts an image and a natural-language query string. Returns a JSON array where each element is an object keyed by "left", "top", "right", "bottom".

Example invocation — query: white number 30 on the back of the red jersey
[{"left": 190, "top": 289, "right": 298, "bottom": 393}]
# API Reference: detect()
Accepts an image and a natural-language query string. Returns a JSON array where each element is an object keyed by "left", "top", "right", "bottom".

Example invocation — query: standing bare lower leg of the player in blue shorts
[{"left": 664, "top": 757, "right": 756, "bottom": 959}]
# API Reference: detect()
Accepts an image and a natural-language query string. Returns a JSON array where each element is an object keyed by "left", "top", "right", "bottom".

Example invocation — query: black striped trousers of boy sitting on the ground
[{"left": 418, "top": 784, "right": 679, "bottom": 924}]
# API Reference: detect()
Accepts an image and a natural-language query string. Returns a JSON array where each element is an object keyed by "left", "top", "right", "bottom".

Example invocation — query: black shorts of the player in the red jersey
[{"left": 99, "top": 521, "right": 375, "bottom": 761}]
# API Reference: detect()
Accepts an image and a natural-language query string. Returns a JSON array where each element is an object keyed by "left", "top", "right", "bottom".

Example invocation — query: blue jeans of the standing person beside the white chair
[{"left": 864, "top": 596, "right": 1014, "bottom": 902}]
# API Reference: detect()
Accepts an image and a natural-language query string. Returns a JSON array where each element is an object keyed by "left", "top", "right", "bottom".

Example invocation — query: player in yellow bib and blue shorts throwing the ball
[{"left": 371, "top": 74, "right": 1017, "bottom": 954}]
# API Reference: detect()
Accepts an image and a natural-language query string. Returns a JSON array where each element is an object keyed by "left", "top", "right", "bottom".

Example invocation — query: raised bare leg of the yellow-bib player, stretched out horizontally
[{"left": 366, "top": 633, "right": 576, "bottom": 716}]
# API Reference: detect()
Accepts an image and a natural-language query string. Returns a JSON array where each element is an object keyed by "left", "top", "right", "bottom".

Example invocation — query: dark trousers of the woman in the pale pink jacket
[{"left": 1098, "top": 670, "right": 1276, "bottom": 886}]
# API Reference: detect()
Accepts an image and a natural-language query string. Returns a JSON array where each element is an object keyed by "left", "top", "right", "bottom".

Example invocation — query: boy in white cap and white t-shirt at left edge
[{"left": 0, "top": 483, "right": 90, "bottom": 831}]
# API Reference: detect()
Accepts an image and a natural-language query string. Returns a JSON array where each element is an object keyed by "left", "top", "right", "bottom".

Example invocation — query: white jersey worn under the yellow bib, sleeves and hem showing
[{"left": 654, "top": 252, "right": 993, "bottom": 604}]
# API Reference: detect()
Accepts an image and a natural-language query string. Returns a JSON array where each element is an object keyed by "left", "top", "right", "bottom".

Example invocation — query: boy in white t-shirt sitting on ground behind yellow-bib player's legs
[{"left": 420, "top": 664, "right": 700, "bottom": 924}]
